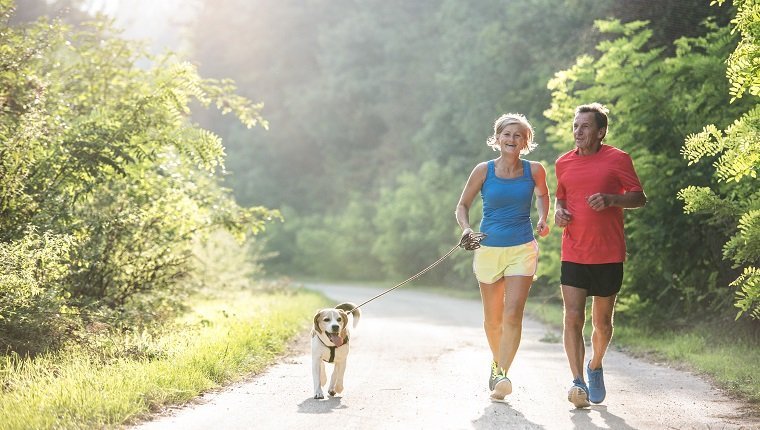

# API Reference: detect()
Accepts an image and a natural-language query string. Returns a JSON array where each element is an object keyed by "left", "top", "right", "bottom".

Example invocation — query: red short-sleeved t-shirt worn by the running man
[{"left": 555, "top": 145, "right": 643, "bottom": 264}]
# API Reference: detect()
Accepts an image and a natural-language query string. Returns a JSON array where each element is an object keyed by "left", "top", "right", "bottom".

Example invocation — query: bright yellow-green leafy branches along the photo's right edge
[{"left": 678, "top": 0, "right": 760, "bottom": 319}]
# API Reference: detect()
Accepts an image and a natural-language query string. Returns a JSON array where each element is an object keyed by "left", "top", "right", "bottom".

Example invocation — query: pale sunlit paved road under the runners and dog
[{"left": 137, "top": 285, "right": 760, "bottom": 430}]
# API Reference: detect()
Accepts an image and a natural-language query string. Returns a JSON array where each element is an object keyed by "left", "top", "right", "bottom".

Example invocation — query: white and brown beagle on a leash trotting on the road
[{"left": 311, "top": 303, "right": 361, "bottom": 399}]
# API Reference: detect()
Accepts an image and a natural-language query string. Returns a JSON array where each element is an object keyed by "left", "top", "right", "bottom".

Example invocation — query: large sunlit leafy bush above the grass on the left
[{"left": 0, "top": 1, "right": 278, "bottom": 351}]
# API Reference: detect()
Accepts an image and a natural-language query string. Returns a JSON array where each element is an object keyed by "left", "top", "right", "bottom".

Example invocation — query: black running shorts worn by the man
[{"left": 560, "top": 261, "right": 623, "bottom": 297}]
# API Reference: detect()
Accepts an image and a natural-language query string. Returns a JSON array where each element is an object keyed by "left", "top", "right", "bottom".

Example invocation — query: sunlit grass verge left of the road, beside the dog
[{"left": 0, "top": 289, "right": 326, "bottom": 430}]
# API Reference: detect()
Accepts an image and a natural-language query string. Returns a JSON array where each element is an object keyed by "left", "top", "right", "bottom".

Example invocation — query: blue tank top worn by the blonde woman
[{"left": 480, "top": 160, "right": 536, "bottom": 246}]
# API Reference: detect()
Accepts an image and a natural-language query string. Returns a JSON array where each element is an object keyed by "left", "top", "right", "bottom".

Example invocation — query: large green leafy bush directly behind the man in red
[{"left": 546, "top": 20, "right": 748, "bottom": 320}]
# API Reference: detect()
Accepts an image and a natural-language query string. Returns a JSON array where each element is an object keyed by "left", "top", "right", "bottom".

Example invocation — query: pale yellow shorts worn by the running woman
[{"left": 472, "top": 240, "right": 538, "bottom": 284}]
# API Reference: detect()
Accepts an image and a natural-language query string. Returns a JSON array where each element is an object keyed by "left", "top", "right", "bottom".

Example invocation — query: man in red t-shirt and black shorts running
[{"left": 554, "top": 103, "right": 647, "bottom": 408}]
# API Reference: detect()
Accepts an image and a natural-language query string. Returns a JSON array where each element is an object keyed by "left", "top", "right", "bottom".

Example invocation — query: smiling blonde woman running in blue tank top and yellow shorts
[{"left": 455, "top": 113, "right": 549, "bottom": 400}]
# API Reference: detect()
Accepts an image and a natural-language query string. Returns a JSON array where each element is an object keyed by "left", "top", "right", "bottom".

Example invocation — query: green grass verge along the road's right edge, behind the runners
[{"left": 526, "top": 299, "right": 760, "bottom": 406}]
